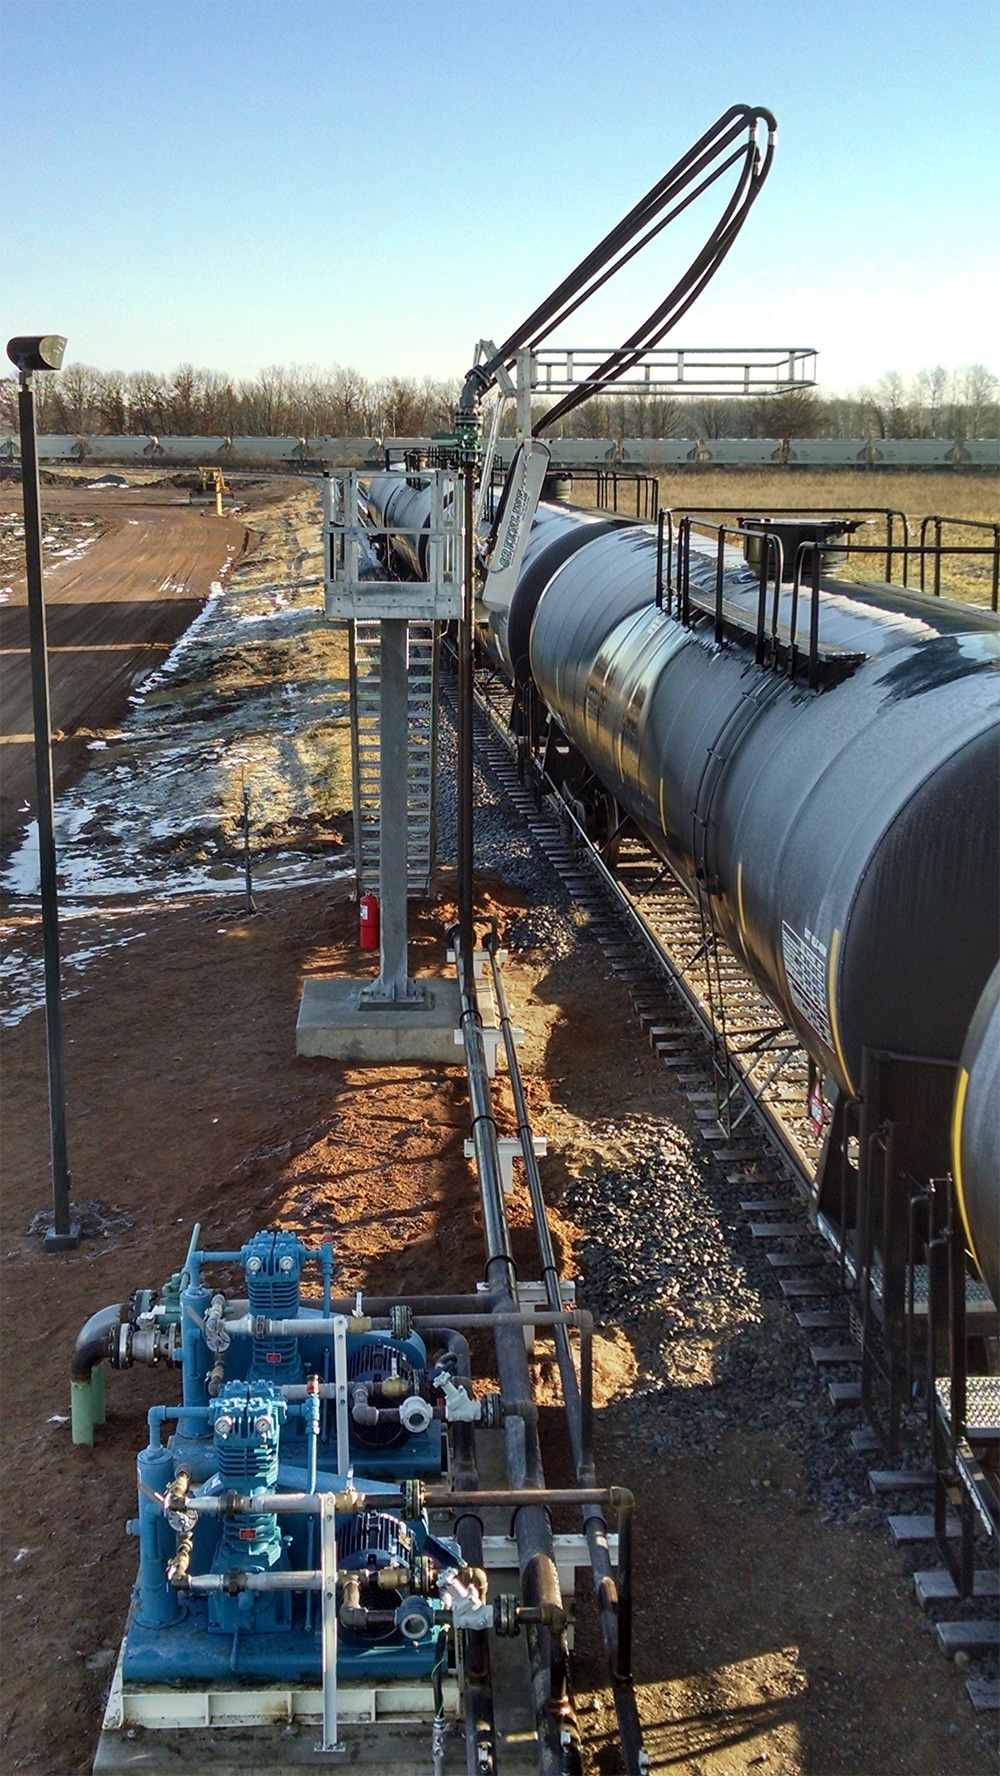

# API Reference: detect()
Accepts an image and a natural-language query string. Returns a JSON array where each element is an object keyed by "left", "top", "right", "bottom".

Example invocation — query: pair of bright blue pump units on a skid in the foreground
[{"left": 123, "top": 1231, "right": 462, "bottom": 1684}]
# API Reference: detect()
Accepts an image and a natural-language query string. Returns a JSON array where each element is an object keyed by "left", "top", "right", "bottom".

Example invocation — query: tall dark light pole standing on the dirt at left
[{"left": 7, "top": 334, "right": 80, "bottom": 1252}]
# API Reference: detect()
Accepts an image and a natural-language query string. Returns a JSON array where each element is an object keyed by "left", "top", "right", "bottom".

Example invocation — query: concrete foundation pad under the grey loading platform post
[{"left": 295, "top": 975, "right": 464, "bottom": 1067}]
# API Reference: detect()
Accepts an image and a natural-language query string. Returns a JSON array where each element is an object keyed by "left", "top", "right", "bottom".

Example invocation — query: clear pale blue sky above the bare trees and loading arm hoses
[{"left": 0, "top": 0, "right": 1000, "bottom": 389}]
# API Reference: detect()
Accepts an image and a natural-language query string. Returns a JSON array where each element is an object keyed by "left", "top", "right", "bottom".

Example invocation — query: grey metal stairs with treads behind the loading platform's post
[{"left": 348, "top": 618, "right": 440, "bottom": 900}]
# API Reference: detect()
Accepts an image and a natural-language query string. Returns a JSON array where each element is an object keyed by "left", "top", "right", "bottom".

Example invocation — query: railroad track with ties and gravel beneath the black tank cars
[{"left": 446, "top": 670, "right": 1000, "bottom": 1710}]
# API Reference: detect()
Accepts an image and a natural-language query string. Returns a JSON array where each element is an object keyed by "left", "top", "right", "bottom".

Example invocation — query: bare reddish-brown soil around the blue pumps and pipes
[{"left": 0, "top": 475, "right": 995, "bottom": 1776}]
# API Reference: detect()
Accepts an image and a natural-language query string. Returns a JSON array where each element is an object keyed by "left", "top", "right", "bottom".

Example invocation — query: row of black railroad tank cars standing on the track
[{"left": 366, "top": 474, "right": 1000, "bottom": 1439}]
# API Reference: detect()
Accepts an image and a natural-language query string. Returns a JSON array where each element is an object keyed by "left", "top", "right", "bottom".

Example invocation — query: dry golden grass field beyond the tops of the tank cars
[{"left": 570, "top": 465, "right": 1000, "bottom": 604}]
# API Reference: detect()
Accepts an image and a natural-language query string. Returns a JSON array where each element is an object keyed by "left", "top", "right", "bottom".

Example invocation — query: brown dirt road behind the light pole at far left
[{"left": 0, "top": 487, "right": 247, "bottom": 844}]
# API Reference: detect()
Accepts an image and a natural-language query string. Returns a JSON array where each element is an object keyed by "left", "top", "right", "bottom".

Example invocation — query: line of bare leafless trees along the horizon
[{"left": 0, "top": 353, "right": 1000, "bottom": 440}]
